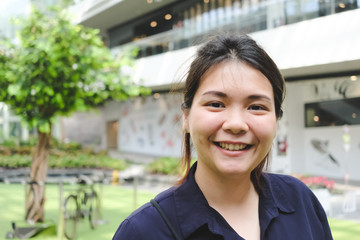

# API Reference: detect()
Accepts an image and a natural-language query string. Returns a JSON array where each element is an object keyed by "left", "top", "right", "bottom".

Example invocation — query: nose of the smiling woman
[{"left": 222, "top": 109, "right": 249, "bottom": 135}]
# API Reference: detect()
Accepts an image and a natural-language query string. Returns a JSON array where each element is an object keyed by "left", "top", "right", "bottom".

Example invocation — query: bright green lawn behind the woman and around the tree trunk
[{"left": 0, "top": 184, "right": 360, "bottom": 240}]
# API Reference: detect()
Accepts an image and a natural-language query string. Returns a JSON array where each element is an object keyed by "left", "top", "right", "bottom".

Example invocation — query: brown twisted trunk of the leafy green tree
[{"left": 25, "top": 127, "right": 51, "bottom": 223}]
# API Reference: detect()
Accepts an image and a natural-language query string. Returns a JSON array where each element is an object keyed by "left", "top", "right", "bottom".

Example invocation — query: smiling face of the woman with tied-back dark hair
[{"left": 184, "top": 61, "right": 276, "bottom": 180}]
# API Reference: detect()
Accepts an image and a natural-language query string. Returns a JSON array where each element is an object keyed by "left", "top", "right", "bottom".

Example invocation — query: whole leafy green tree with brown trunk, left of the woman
[{"left": 0, "top": 6, "right": 149, "bottom": 222}]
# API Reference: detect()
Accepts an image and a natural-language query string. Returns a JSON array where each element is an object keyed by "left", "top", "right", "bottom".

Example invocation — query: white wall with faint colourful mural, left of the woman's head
[{"left": 118, "top": 94, "right": 182, "bottom": 156}]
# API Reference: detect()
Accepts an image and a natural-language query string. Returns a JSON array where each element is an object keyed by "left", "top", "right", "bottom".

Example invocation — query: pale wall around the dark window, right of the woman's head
[{"left": 286, "top": 77, "right": 360, "bottom": 180}]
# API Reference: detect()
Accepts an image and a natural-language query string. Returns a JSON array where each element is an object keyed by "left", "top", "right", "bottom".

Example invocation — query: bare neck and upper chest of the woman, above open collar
[{"left": 195, "top": 164, "right": 260, "bottom": 239}]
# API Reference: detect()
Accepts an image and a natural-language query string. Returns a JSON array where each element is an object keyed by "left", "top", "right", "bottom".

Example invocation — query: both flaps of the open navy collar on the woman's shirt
[{"left": 174, "top": 162, "right": 295, "bottom": 239}]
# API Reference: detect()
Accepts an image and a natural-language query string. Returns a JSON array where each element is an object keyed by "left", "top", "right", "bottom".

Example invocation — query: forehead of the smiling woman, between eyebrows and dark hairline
[{"left": 197, "top": 61, "right": 273, "bottom": 95}]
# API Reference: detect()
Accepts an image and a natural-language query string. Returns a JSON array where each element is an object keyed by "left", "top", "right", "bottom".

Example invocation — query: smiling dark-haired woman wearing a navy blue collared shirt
[{"left": 113, "top": 34, "right": 332, "bottom": 240}]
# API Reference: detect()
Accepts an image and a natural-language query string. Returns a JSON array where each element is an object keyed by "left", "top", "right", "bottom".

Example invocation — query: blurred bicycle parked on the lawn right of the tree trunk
[{"left": 64, "top": 175, "right": 100, "bottom": 240}]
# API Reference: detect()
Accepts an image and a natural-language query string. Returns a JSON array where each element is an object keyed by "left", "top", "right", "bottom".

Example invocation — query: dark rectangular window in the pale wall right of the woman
[{"left": 305, "top": 97, "right": 360, "bottom": 127}]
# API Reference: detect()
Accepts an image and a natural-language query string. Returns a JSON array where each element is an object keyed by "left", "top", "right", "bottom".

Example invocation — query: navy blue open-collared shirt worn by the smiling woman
[{"left": 113, "top": 164, "right": 332, "bottom": 240}]
